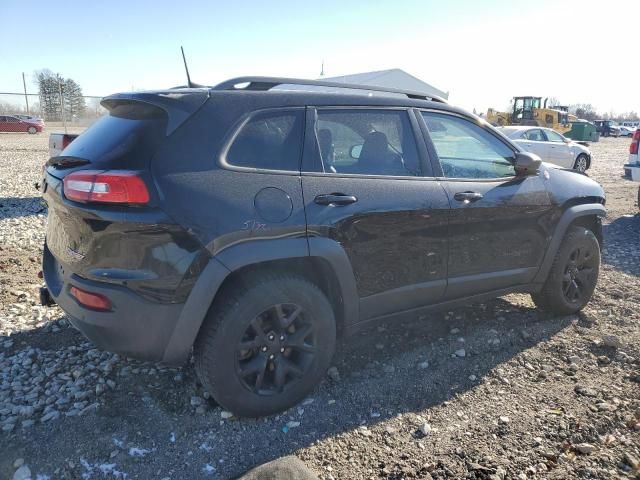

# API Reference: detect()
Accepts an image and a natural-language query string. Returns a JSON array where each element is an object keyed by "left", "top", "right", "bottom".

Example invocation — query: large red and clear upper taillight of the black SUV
[{"left": 64, "top": 170, "right": 149, "bottom": 205}]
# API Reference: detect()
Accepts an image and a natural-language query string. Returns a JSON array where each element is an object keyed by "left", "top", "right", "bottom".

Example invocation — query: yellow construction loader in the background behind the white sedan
[{"left": 486, "top": 97, "right": 576, "bottom": 133}]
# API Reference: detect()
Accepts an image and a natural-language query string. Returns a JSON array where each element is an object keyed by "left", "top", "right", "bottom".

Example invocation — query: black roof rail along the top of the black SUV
[{"left": 212, "top": 77, "right": 447, "bottom": 103}]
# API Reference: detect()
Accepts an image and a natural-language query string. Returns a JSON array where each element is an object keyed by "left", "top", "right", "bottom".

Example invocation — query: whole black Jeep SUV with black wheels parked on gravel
[{"left": 42, "top": 77, "right": 605, "bottom": 416}]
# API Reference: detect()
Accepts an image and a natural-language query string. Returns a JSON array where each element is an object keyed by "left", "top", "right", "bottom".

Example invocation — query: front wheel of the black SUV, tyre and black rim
[{"left": 531, "top": 226, "right": 600, "bottom": 315}]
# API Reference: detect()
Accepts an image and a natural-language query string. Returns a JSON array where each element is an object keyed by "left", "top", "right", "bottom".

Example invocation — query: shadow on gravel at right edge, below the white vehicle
[{"left": 602, "top": 215, "right": 640, "bottom": 276}]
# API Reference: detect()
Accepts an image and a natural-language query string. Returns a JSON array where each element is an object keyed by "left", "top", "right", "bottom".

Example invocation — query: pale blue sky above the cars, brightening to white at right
[{"left": 0, "top": 0, "right": 640, "bottom": 112}]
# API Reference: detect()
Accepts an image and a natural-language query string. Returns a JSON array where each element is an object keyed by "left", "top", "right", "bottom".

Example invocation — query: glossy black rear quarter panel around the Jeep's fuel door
[{"left": 151, "top": 98, "right": 306, "bottom": 255}]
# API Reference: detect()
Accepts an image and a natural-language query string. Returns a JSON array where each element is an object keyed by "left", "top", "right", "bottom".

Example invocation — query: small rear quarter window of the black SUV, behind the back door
[{"left": 226, "top": 110, "right": 304, "bottom": 172}]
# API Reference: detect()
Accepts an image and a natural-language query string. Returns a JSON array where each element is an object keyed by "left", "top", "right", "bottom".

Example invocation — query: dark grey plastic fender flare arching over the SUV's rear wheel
[{"left": 162, "top": 237, "right": 359, "bottom": 365}]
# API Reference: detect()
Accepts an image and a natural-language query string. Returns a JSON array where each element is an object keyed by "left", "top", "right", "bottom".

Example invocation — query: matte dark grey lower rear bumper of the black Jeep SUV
[{"left": 43, "top": 244, "right": 184, "bottom": 364}]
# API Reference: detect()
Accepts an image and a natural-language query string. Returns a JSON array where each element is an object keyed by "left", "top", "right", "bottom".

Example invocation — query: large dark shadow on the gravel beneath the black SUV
[{"left": 0, "top": 297, "right": 576, "bottom": 478}]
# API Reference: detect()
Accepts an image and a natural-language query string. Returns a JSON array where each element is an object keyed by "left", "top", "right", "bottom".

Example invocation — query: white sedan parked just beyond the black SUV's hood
[{"left": 499, "top": 127, "right": 591, "bottom": 173}]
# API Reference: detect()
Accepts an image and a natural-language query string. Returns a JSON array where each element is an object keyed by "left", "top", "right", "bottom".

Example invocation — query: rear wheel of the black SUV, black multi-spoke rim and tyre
[{"left": 194, "top": 273, "right": 336, "bottom": 417}]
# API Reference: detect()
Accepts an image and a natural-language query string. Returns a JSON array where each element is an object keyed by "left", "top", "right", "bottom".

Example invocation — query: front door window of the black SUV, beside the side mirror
[{"left": 422, "top": 112, "right": 516, "bottom": 179}]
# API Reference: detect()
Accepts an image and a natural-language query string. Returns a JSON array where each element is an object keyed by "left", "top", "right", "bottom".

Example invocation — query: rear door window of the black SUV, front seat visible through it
[{"left": 316, "top": 109, "right": 420, "bottom": 176}]
